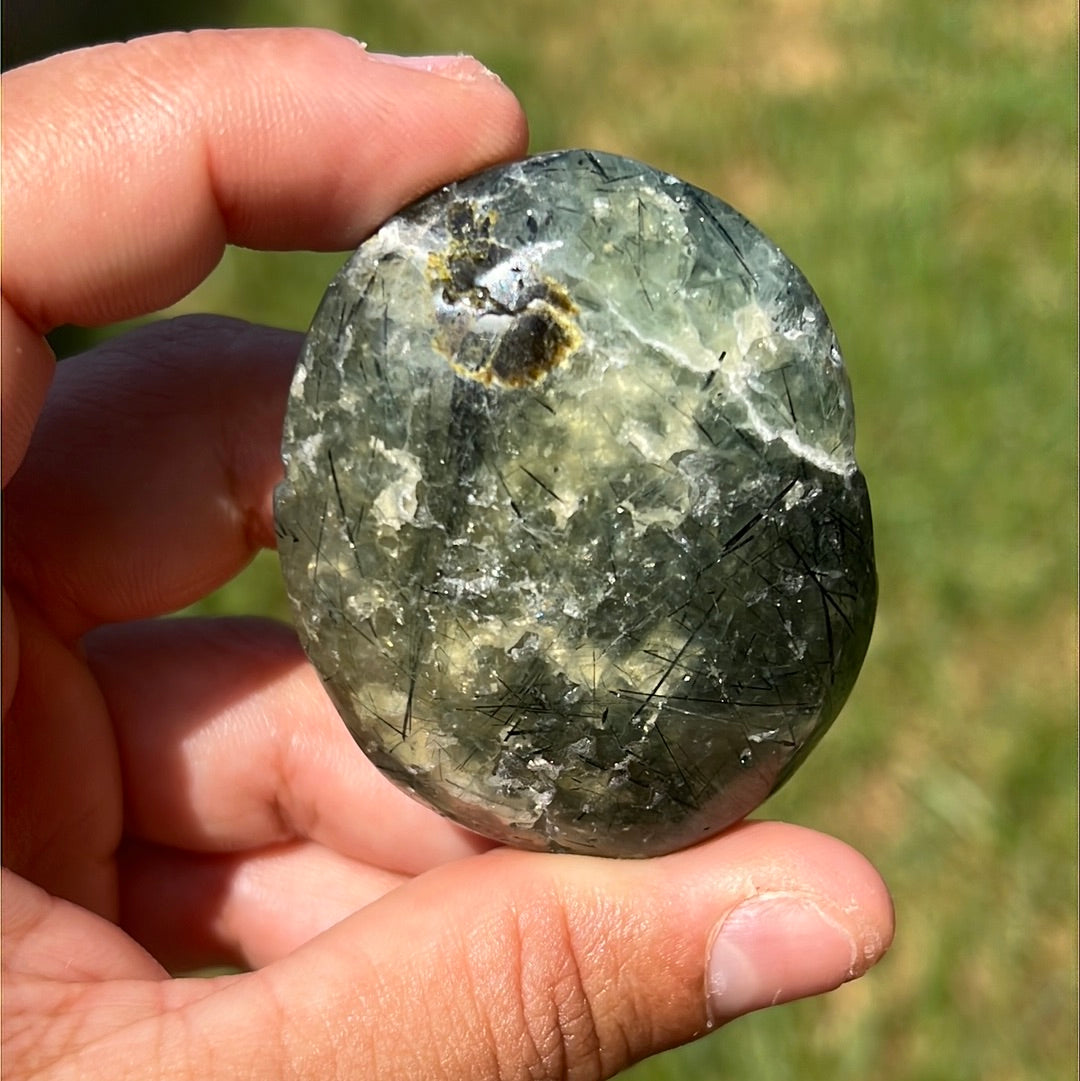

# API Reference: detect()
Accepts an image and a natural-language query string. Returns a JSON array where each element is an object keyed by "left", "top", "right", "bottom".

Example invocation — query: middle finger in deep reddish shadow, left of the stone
[{"left": 4, "top": 317, "right": 299, "bottom": 640}]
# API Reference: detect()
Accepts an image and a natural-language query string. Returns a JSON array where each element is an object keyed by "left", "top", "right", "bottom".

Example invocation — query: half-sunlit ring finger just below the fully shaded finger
[{"left": 85, "top": 619, "right": 490, "bottom": 873}]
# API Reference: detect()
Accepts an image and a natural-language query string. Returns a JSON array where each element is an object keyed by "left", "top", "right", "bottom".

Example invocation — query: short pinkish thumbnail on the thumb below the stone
[{"left": 706, "top": 893, "right": 866, "bottom": 1025}]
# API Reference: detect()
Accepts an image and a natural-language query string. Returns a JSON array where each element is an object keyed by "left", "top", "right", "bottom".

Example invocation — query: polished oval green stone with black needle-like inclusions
[{"left": 277, "top": 150, "right": 877, "bottom": 856}]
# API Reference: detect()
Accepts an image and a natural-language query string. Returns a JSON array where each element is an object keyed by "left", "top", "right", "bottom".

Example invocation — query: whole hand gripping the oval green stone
[{"left": 2, "top": 30, "right": 892, "bottom": 1079}]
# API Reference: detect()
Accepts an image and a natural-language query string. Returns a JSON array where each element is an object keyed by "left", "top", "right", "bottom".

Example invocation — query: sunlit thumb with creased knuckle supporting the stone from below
[{"left": 206, "top": 823, "right": 893, "bottom": 1079}]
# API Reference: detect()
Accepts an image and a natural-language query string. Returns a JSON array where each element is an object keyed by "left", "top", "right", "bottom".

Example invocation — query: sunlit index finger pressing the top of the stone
[{"left": 2, "top": 29, "right": 525, "bottom": 332}]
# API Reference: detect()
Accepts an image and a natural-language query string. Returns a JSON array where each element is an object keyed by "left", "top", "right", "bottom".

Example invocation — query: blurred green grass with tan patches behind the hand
[{"left": 6, "top": 0, "right": 1077, "bottom": 1081}]
